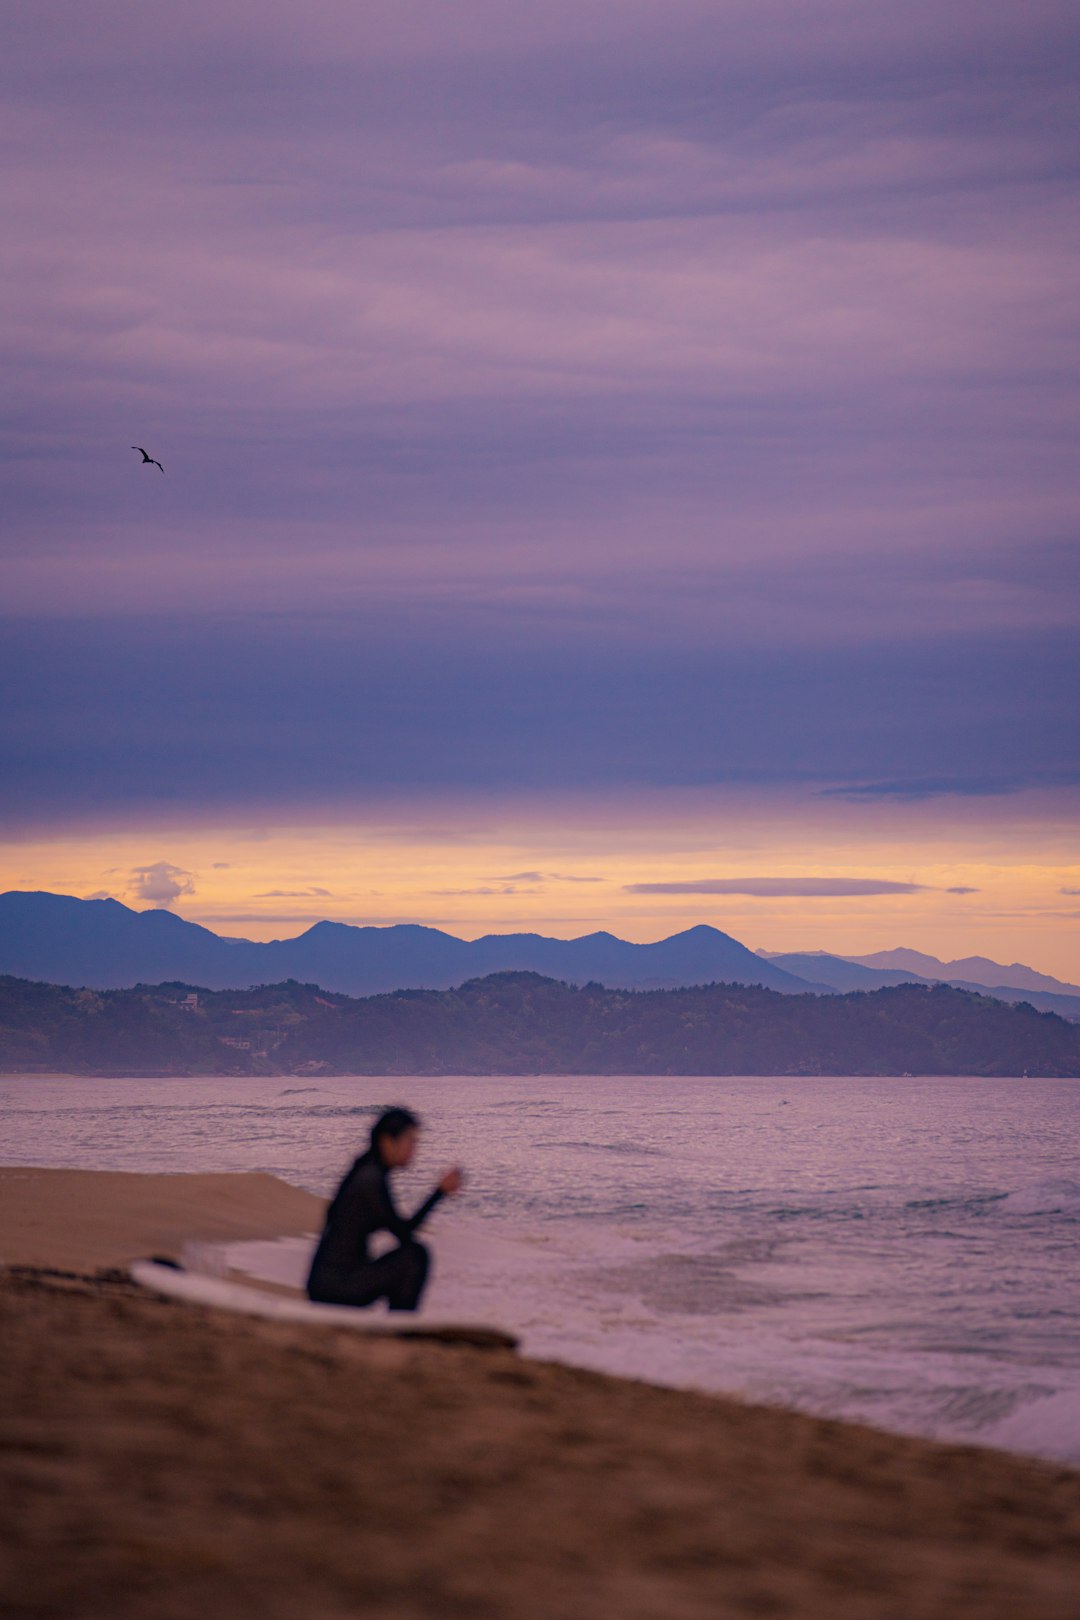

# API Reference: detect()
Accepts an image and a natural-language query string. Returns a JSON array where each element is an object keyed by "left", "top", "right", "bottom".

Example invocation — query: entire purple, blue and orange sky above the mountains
[{"left": 0, "top": 0, "right": 1080, "bottom": 978}]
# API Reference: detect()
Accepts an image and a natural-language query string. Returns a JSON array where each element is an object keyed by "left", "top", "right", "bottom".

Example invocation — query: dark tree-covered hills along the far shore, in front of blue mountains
[{"left": 0, "top": 974, "right": 1080, "bottom": 1077}]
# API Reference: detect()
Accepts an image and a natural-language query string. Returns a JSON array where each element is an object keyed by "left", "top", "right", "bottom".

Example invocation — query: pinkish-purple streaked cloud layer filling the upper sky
[{"left": 0, "top": 0, "right": 1075, "bottom": 637}]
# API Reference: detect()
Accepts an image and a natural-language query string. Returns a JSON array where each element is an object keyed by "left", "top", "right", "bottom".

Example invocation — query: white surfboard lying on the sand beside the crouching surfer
[{"left": 128, "top": 1260, "right": 518, "bottom": 1349}]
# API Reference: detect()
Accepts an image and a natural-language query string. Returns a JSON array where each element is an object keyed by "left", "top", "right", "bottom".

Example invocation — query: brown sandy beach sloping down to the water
[{"left": 0, "top": 1171, "right": 1080, "bottom": 1620}]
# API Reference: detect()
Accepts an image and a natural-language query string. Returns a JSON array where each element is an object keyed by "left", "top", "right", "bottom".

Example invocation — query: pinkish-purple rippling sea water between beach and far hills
[{"left": 0, "top": 1076, "right": 1080, "bottom": 1463}]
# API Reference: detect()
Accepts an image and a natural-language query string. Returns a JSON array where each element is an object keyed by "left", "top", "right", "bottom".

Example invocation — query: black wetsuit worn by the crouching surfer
[{"left": 308, "top": 1149, "right": 442, "bottom": 1311}]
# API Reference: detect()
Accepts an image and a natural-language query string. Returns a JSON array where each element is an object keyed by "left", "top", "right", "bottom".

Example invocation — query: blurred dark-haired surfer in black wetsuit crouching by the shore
[{"left": 308, "top": 1108, "right": 463, "bottom": 1311}]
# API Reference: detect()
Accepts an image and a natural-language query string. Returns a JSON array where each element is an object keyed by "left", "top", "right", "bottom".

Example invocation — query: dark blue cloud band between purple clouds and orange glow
[{"left": 0, "top": 612, "right": 1080, "bottom": 835}]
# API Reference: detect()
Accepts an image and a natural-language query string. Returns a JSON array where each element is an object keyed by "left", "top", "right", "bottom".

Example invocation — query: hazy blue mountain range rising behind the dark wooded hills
[{"left": 0, "top": 889, "right": 1080, "bottom": 1021}]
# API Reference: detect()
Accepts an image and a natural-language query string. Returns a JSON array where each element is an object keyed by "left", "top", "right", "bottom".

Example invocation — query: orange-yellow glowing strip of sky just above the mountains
[{"left": 0, "top": 780, "right": 1080, "bottom": 980}]
